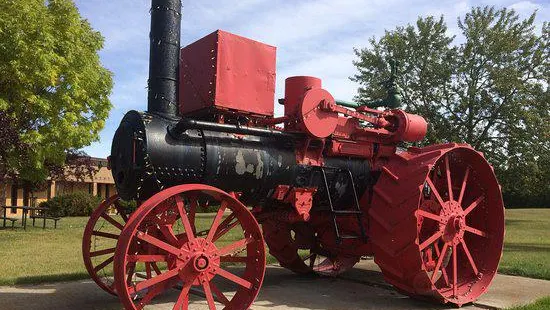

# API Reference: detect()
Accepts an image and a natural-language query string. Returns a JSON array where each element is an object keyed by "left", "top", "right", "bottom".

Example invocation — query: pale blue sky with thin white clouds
[{"left": 75, "top": 0, "right": 550, "bottom": 157}]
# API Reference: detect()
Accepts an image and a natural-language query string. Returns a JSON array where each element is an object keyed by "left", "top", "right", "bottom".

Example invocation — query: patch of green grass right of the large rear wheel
[{"left": 498, "top": 209, "right": 550, "bottom": 280}]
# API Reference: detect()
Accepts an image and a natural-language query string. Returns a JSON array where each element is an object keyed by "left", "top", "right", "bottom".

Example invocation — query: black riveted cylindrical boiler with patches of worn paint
[{"left": 111, "top": 111, "right": 370, "bottom": 209}]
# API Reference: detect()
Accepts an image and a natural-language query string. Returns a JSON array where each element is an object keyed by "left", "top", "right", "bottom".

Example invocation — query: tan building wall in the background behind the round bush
[{"left": 0, "top": 160, "right": 116, "bottom": 217}]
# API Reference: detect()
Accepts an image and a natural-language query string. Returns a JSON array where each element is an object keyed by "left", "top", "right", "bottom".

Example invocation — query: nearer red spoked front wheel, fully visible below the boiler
[{"left": 115, "top": 184, "right": 265, "bottom": 309}]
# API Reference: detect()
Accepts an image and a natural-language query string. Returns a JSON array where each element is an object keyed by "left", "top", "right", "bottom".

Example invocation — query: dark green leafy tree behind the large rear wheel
[{"left": 351, "top": 7, "right": 550, "bottom": 204}]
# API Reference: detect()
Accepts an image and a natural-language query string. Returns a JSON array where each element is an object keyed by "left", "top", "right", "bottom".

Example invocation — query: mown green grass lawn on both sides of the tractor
[{"left": 0, "top": 209, "right": 550, "bottom": 286}]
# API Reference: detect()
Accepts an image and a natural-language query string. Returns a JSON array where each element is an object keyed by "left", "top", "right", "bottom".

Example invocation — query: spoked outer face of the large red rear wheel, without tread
[{"left": 416, "top": 149, "right": 504, "bottom": 304}]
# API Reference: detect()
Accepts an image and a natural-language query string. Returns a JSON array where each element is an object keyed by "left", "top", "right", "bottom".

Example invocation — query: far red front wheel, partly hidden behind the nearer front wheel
[{"left": 82, "top": 195, "right": 128, "bottom": 295}]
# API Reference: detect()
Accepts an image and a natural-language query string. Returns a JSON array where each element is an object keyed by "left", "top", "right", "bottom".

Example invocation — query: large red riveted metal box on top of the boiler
[{"left": 180, "top": 30, "right": 276, "bottom": 116}]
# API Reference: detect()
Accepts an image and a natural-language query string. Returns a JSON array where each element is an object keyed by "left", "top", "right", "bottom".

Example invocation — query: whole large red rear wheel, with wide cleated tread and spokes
[{"left": 369, "top": 144, "right": 504, "bottom": 306}]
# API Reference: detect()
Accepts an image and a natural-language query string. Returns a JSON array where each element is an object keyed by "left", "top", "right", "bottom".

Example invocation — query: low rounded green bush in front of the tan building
[{"left": 40, "top": 192, "right": 102, "bottom": 217}]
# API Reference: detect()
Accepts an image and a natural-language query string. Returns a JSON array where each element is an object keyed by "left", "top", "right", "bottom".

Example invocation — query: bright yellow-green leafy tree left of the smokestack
[{"left": 0, "top": 0, "right": 113, "bottom": 208}]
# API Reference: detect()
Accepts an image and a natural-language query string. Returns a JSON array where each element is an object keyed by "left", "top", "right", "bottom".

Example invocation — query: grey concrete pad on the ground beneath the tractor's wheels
[{"left": 0, "top": 261, "right": 550, "bottom": 310}]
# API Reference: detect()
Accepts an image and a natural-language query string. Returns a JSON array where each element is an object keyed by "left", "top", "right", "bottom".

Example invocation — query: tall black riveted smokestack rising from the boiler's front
[{"left": 147, "top": 0, "right": 181, "bottom": 116}]
